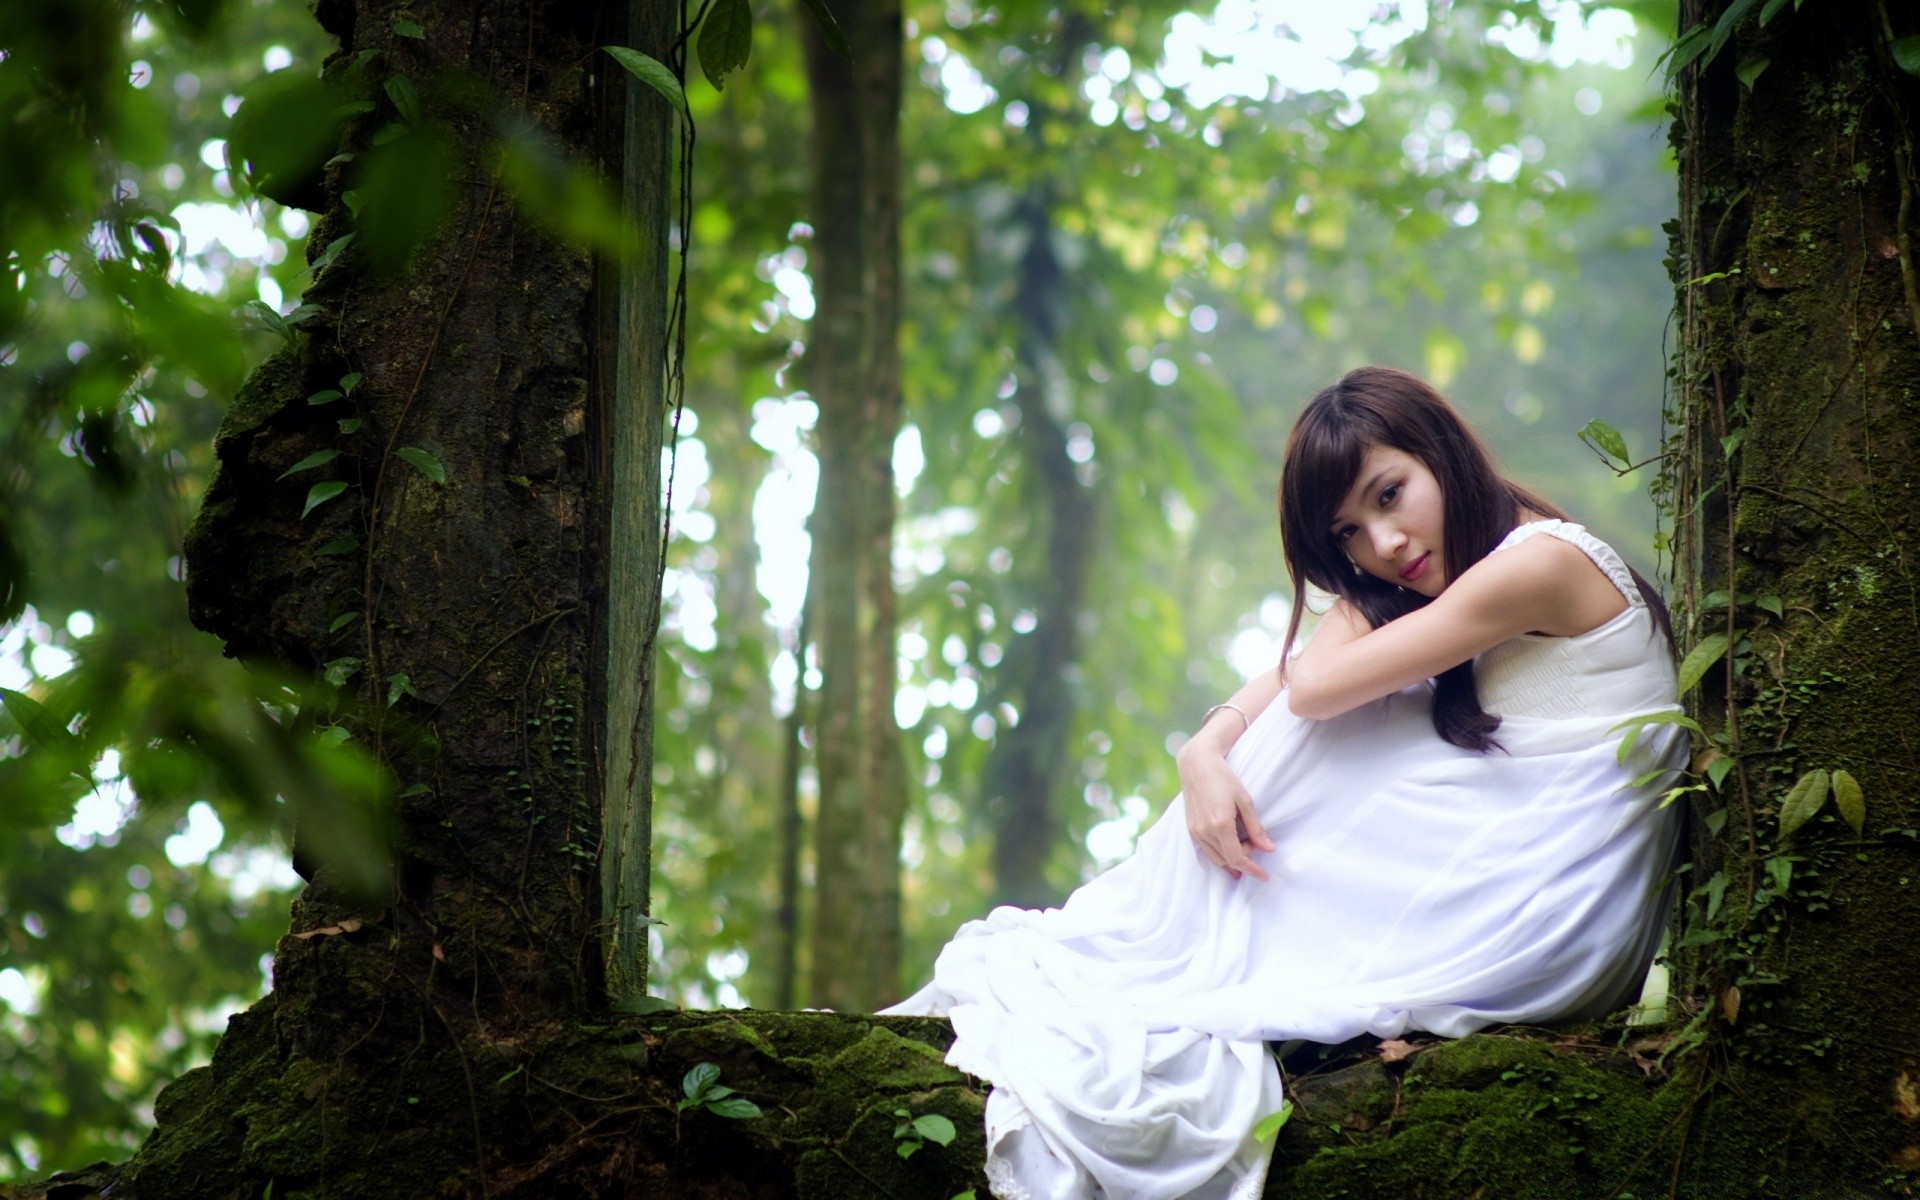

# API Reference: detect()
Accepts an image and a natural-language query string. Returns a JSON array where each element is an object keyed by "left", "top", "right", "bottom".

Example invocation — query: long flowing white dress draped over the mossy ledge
[{"left": 889, "top": 520, "right": 1684, "bottom": 1200}]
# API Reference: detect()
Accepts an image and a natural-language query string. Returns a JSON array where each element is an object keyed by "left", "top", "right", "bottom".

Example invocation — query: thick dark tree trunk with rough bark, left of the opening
[{"left": 86, "top": 0, "right": 674, "bottom": 1196}]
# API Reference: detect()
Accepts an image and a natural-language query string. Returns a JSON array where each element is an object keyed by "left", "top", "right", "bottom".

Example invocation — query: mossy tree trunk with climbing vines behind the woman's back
[{"left": 1668, "top": 0, "right": 1920, "bottom": 1194}]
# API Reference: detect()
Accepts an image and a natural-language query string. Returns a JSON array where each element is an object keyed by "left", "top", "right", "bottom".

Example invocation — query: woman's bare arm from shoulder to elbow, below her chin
[{"left": 1286, "top": 538, "right": 1626, "bottom": 720}]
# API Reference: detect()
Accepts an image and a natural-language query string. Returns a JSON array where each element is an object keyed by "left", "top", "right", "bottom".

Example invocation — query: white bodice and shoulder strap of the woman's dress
[{"left": 1473, "top": 520, "right": 1674, "bottom": 718}]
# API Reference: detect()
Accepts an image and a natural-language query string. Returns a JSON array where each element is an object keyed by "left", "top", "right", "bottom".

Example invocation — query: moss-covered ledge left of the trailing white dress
[{"left": 0, "top": 1000, "right": 987, "bottom": 1200}]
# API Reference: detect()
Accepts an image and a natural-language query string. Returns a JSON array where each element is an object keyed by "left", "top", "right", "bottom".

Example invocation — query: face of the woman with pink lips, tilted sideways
[{"left": 1327, "top": 445, "right": 1446, "bottom": 597}]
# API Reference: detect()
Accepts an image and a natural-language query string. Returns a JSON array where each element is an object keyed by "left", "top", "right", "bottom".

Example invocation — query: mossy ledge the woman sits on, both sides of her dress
[{"left": 0, "top": 998, "right": 1692, "bottom": 1200}]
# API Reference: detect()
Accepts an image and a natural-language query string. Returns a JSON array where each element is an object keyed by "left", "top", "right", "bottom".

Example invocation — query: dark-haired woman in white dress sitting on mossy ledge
[{"left": 891, "top": 367, "right": 1684, "bottom": 1200}]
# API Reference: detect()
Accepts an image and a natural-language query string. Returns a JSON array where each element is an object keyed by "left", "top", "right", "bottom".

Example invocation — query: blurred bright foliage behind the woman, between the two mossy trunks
[{"left": 655, "top": 2, "right": 1674, "bottom": 1004}]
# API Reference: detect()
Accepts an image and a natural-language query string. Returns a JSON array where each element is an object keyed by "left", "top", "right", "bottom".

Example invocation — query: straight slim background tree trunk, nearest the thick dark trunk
[{"left": 799, "top": 0, "right": 906, "bottom": 1012}]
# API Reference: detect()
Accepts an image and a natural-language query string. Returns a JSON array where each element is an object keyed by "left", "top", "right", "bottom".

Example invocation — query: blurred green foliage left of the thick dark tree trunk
[{"left": 0, "top": 2, "right": 341, "bottom": 1177}]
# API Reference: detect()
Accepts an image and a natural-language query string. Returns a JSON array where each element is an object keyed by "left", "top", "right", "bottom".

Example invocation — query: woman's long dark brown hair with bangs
[{"left": 1281, "top": 367, "right": 1672, "bottom": 751}]
